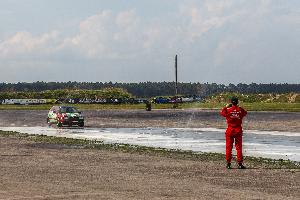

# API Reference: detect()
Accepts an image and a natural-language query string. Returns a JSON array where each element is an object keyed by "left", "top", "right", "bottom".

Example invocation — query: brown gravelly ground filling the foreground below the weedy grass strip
[{"left": 0, "top": 137, "right": 300, "bottom": 199}]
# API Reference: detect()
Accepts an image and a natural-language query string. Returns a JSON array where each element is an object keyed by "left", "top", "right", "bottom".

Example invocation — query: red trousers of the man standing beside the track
[{"left": 225, "top": 126, "right": 243, "bottom": 163}]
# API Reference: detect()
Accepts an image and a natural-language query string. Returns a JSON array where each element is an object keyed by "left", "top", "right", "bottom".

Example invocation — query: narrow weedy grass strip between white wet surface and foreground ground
[{"left": 0, "top": 131, "right": 300, "bottom": 170}]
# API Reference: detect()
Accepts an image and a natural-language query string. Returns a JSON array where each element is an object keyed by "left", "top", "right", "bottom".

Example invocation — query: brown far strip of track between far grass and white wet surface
[{"left": 0, "top": 109, "right": 300, "bottom": 132}]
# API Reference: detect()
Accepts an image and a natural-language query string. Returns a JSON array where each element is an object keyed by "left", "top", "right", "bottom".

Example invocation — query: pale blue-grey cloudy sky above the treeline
[{"left": 0, "top": 0, "right": 300, "bottom": 84}]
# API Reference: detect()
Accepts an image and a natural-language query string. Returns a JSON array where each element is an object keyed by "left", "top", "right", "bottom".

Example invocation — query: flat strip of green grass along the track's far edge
[{"left": 0, "top": 103, "right": 300, "bottom": 112}]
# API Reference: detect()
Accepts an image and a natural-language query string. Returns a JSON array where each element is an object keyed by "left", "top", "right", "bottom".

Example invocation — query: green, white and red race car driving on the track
[{"left": 47, "top": 106, "right": 84, "bottom": 127}]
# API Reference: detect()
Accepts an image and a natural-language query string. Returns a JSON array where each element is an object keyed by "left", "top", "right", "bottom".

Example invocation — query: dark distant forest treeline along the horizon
[{"left": 0, "top": 81, "right": 300, "bottom": 97}]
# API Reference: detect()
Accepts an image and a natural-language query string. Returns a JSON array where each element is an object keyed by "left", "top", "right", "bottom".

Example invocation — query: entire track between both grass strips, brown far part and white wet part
[{"left": 0, "top": 109, "right": 300, "bottom": 161}]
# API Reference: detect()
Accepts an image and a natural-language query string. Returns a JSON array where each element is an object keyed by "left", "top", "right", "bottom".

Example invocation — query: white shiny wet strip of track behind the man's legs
[{"left": 0, "top": 127, "right": 300, "bottom": 161}]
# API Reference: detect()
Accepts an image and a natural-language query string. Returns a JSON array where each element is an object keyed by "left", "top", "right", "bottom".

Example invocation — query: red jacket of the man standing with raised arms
[{"left": 220, "top": 105, "right": 247, "bottom": 127}]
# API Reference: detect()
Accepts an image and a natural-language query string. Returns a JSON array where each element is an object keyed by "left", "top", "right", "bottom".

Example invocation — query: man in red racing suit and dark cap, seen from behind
[{"left": 220, "top": 97, "right": 247, "bottom": 169}]
